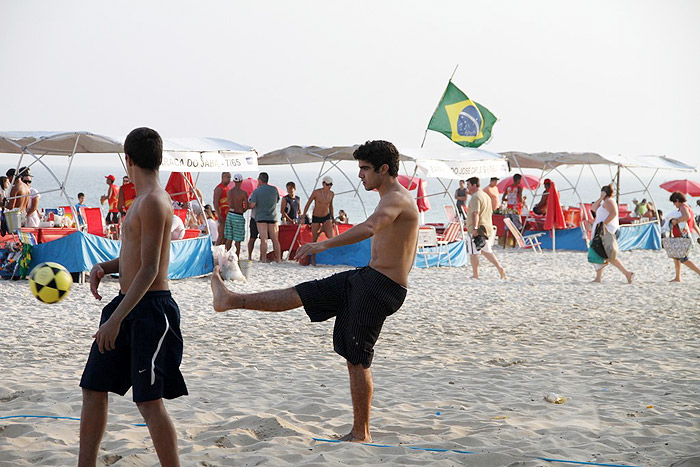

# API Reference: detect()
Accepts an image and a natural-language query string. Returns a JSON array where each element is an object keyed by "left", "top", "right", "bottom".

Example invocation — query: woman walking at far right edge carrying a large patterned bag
[{"left": 663, "top": 191, "right": 700, "bottom": 282}]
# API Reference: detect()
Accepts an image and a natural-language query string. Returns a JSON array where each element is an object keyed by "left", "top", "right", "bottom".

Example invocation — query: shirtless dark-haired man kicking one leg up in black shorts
[{"left": 212, "top": 141, "right": 418, "bottom": 442}]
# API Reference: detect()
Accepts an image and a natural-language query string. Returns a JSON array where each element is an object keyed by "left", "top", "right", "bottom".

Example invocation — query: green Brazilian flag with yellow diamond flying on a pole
[{"left": 428, "top": 81, "right": 496, "bottom": 148}]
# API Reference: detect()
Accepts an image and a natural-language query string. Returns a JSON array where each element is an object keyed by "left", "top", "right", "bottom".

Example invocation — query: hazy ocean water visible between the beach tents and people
[{"left": 0, "top": 155, "right": 700, "bottom": 223}]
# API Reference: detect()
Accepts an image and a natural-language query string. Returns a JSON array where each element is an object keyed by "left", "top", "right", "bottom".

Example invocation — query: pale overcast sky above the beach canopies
[{"left": 0, "top": 0, "right": 700, "bottom": 165}]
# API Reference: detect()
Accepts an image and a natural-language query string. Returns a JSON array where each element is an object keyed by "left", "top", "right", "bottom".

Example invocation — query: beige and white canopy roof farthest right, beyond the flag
[{"left": 501, "top": 151, "right": 695, "bottom": 171}]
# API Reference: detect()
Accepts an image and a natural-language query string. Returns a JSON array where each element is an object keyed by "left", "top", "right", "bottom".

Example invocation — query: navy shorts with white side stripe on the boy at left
[{"left": 80, "top": 290, "right": 187, "bottom": 402}]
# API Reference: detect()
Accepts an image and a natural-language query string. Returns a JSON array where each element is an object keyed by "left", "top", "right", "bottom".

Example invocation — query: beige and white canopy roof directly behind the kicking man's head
[{"left": 258, "top": 145, "right": 508, "bottom": 179}]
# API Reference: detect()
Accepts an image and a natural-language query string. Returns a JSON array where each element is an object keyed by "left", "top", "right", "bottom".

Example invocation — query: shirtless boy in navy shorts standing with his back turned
[{"left": 78, "top": 128, "right": 187, "bottom": 467}]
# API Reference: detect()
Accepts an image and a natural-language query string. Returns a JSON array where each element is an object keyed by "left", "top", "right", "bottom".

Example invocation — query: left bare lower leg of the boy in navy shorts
[{"left": 78, "top": 389, "right": 108, "bottom": 467}]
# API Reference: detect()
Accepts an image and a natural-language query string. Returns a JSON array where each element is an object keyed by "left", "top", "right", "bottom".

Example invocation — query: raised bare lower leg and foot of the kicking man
[{"left": 211, "top": 266, "right": 302, "bottom": 311}]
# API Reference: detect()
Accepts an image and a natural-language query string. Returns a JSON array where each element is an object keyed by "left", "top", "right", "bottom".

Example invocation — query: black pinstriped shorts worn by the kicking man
[{"left": 296, "top": 266, "right": 407, "bottom": 368}]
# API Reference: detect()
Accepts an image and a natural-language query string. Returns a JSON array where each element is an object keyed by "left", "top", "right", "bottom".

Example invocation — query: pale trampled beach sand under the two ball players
[{"left": 0, "top": 249, "right": 700, "bottom": 466}]
